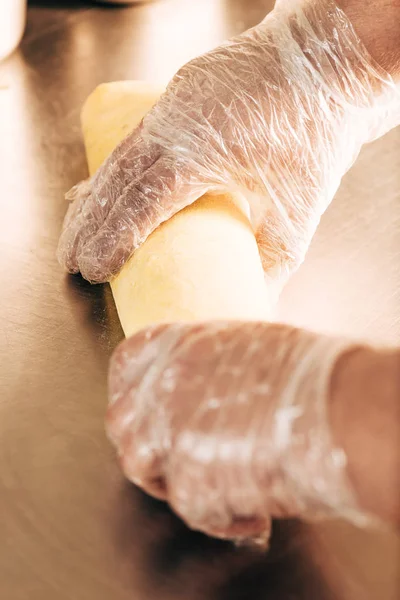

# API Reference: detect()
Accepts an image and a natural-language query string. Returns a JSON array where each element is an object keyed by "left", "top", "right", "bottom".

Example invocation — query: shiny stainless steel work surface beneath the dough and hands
[{"left": 0, "top": 0, "right": 400, "bottom": 600}]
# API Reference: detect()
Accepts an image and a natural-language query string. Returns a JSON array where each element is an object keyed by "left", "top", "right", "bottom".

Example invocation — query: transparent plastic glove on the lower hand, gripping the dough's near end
[{"left": 107, "top": 323, "right": 365, "bottom": 538}]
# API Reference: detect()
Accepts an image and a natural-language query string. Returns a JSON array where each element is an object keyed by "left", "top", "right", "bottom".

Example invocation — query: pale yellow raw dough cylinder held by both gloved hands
[{"left": 81, "top": 81, "right": 271, "bottom": 336}]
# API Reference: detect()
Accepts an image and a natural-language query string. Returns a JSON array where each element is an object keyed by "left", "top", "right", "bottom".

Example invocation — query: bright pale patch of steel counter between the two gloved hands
[{"left": 280, "top": 128, "right": 400, "bottom": 345}]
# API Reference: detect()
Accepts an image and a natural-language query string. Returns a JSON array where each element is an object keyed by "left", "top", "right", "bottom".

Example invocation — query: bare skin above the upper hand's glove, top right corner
[{"left": 336, "top": 0, "right": 400, "bottom": 82}]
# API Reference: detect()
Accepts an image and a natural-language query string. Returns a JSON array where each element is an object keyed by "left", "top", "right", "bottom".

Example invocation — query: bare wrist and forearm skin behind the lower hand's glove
[{"left": 330, "top": 347, "right": 400, "bottom": 527}]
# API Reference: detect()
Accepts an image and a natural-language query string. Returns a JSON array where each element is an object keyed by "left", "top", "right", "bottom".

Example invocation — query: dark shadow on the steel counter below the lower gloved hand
[{"left": 114, "top": 482, "right": 334, "bottom": 600}]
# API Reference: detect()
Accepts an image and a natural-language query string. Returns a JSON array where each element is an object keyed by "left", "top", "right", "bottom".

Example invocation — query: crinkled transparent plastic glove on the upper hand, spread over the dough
[{"left": 59, "top": 0, "right": 400, "bottom": 288}]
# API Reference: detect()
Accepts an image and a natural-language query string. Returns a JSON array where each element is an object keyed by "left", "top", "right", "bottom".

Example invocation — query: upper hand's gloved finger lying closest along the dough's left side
[{"left": 77, "top": 154, "right": 207, "bottom": 282}]
